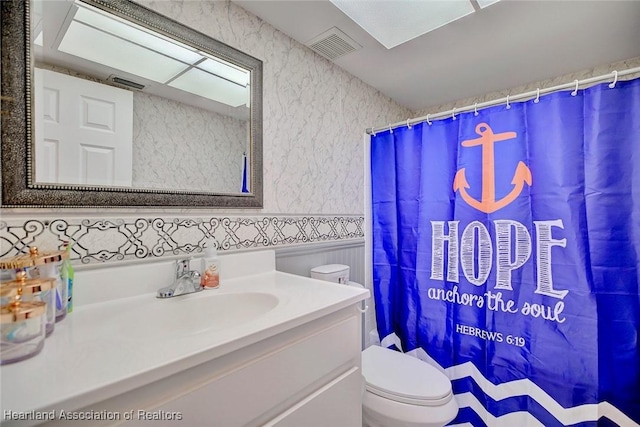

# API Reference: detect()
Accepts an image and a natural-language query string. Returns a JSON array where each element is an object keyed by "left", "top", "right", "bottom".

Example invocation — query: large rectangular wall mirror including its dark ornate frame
[{"left": 1, "top": 0, "right": 262, "bottom": 208}]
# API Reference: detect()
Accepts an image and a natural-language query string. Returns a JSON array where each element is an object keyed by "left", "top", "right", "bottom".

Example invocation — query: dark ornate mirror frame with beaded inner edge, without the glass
[{"left": 0, "top": 0, "right": 263, "bottom": 208}]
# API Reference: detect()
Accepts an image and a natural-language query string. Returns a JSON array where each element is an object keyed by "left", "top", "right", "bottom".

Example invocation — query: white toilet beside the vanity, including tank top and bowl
[{"left": 311, "top": 264, "right": 458, "bottom": 427}]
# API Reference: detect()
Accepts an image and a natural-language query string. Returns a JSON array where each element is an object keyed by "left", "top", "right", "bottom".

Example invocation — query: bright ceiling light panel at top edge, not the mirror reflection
[{"left": 331, "top": 0, "right": 499, "bottom": 49}]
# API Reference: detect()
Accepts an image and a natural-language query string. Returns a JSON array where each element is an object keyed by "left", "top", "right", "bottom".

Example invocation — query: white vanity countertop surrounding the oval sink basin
[{"left": 0, "top": 271, "right": 369, "bottom": 422}]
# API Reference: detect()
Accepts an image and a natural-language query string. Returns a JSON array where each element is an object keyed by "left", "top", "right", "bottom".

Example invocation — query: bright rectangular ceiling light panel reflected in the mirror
[{"left": 58, "top": 2, "right": 251, "bottom": 107}]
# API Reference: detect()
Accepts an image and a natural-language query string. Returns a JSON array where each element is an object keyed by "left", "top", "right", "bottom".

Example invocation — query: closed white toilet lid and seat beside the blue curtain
[{"left": 362, "top": 346, "right": 452, "bottom": 406}]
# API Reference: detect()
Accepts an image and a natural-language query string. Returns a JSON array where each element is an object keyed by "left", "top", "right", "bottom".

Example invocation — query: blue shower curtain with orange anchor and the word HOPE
[{"left": 371, "top": 79, "right": 640, "bottom": 427}]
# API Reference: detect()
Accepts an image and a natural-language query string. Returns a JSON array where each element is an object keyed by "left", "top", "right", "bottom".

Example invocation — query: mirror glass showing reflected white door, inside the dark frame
[{"left": 32, "top": 0, "right": 251, "bottom": 193}]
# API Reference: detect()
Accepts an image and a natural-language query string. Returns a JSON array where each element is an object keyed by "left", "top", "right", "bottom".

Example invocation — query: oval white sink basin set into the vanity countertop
[{"left": 110, "top": 290, "right": 278, "bottom": 340}]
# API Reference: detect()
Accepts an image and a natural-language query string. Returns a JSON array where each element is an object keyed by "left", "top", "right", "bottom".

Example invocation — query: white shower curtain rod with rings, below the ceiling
[{"left": 365, "top": 67, "right": 640, "bottom": 134}]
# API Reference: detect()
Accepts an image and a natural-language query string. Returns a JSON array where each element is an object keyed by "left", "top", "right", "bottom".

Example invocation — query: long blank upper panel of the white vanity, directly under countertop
[{"left": 125, "top": 316, "right": 360, "bottom": 427}]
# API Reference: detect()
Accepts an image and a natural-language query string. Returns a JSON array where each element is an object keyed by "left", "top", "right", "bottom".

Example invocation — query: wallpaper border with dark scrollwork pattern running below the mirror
[{"left": 0, "top": 216, "right": 364, "bottom": 264}]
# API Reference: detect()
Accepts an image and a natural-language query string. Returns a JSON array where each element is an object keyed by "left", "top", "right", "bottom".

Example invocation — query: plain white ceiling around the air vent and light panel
[{"left": 233, "top": 0, "right": 640, "bottom": 111}]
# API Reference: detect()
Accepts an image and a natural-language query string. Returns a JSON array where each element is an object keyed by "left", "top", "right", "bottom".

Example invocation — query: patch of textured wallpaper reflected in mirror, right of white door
[{"left": 133, "top": 92, "right": 249, "bottom": 193}]
